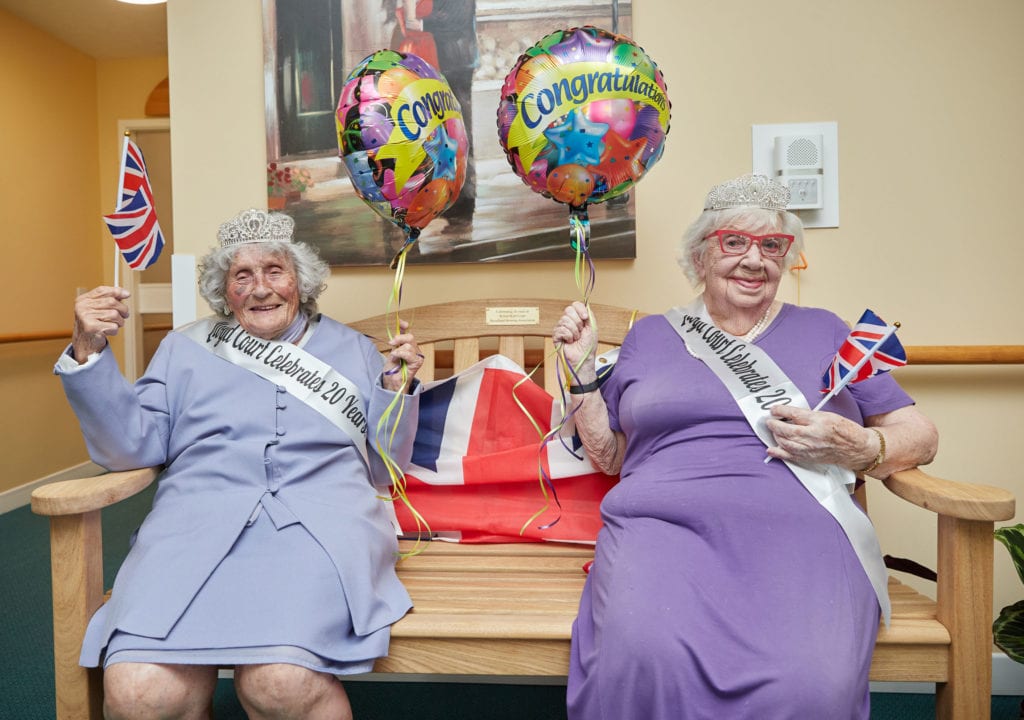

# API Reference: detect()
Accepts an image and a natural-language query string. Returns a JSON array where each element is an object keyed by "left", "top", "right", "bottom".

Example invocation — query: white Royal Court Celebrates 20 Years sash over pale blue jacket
[{"left": 177, "top": 315, "right": 370, "bottom": 467}]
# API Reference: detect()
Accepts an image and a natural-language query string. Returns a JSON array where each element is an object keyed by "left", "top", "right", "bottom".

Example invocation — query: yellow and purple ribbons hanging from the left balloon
[{"left": 375, "top": 240, "right": 430, "bottom": 558}]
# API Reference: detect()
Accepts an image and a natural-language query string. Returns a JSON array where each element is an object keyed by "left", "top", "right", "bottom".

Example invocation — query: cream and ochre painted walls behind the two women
[{"left": 0, "top": 0, "right": 1024, "bottom": 618}]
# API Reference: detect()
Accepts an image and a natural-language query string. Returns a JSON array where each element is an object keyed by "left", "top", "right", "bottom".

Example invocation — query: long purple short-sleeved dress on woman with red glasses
[{"left": 568, "top": 305, "right": 912, "bottom": 720}]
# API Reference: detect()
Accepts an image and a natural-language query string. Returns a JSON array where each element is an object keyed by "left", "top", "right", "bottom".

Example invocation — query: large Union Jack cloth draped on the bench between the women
[{"left": 395, "top": 355, "right": 618, "bottom": 543}]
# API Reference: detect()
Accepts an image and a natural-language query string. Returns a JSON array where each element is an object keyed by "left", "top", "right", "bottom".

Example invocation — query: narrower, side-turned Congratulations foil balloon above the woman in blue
[{"left": 335, "top": 50, "right": 469, "bottom": 245}]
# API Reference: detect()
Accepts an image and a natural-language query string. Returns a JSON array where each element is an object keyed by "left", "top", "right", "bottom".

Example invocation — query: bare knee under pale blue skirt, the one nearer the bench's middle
[{"left": 234, "top": 664, "right": 352, "bottom": 720}]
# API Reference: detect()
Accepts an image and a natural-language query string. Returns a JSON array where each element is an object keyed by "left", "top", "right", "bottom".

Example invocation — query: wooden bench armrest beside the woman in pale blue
[{"left": 32, "top": 467, "right": 162, "bottom": 517}]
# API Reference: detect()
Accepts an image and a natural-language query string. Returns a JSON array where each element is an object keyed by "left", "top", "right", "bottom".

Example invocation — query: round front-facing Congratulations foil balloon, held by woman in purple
[{"left": 498, "top": 26, "right": 672, "bottom": 208}]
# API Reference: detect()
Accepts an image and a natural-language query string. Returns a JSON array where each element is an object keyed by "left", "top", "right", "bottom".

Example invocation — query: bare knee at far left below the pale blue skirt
[{"left": 103, "top": 663, "right": 217, "bottom": 720}]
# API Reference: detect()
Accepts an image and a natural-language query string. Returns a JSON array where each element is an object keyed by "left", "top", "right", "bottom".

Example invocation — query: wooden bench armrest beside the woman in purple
[{"left": 883, "top": 468, "right": 1016, "bottom": 522}]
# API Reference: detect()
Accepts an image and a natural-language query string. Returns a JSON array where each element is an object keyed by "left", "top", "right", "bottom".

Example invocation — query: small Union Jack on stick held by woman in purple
[{"left": 815, "top": 310, "right": 906, "bottom": 410}]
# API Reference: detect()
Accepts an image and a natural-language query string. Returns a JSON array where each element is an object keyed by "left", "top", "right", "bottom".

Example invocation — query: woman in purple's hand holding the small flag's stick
[{"left": 767, "top": 405, "right": 877, "bottom": 470}]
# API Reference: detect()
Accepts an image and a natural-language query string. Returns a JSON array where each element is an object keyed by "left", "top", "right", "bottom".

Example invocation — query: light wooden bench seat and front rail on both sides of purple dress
[{"left": 385, "top": 541, "right": 950, "bottom": 682}]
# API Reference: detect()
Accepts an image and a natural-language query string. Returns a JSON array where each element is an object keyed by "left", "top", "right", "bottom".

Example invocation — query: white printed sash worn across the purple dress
[{"left": 665, "top": 297, "right": 892, "bottom": 627}]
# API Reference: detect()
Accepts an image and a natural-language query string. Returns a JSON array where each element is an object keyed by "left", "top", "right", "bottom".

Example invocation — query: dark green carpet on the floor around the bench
[{"left": 0, "top": 489, "right": 1021, "bottom": 720}]
